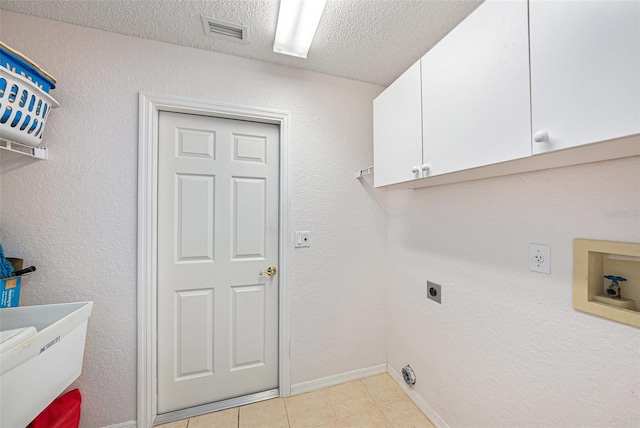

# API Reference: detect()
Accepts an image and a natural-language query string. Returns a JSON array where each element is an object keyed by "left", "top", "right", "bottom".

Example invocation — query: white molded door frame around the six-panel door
[{"left": 137, "top": 92, "right": 291, "bottom": 428}]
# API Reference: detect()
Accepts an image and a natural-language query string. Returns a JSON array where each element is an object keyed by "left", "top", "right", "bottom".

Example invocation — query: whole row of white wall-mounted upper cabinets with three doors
[{"left": 373, "top": 0, "right": 640, "bottom": 187}]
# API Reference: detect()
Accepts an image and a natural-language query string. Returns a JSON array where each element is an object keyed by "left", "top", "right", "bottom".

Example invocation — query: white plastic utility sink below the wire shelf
[{"left": 0, "top": 302, "right": 93, "bottom": 428}]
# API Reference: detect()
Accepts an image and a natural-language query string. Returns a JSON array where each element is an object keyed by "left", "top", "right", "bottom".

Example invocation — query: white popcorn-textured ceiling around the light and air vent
[{"left": 0, "top": 0, "right": 482, "bottom": 86}]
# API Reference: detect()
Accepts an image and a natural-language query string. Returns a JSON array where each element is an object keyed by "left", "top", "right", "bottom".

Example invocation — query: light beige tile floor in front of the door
[{"left": 157, "top": 373, "right": 435, "bottom": 428}]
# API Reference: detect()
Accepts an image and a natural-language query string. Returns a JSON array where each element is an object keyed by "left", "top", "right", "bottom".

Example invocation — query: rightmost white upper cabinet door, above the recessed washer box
[{"left": 529, "top": 0, "right": 640, "bottom": 153}]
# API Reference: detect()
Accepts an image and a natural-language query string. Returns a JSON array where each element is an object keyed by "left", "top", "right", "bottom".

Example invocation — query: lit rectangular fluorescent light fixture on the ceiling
[{"left": 273, "top": 0, "right": 327, "bottom": 58}]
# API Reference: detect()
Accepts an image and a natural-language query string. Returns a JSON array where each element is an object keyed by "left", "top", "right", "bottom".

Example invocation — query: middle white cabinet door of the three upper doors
[{"left": 422, "top": 0, "right": 531, "bottom": 176}]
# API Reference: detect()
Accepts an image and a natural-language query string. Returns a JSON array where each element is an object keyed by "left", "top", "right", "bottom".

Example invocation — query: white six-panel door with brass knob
[{"left": 157, "top": 112, "right": 279, "bottom": 414}]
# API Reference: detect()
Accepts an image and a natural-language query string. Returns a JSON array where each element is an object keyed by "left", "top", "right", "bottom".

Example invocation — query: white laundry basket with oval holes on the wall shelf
[{"left": 0, "top": 68, "right": 60, "bottom": 146}]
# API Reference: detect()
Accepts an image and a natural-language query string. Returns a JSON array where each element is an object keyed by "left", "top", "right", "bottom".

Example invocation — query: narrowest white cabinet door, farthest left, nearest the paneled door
[{"left": 373, "top": 61, "right": 422, "bottom": 187}]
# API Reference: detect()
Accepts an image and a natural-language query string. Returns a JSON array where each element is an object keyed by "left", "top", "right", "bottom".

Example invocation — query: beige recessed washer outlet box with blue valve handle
[{"left": 573, "top": 239, "right": 640, "bottom": 327}]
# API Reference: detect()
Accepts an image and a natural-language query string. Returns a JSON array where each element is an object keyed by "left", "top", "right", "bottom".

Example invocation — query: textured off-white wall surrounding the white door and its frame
[{"left": 0, "top": 11, "right": 387, "bottom": 427}]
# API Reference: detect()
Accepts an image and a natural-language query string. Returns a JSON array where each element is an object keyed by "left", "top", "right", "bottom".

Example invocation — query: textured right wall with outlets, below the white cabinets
[{"left": 387, "top": 157, "right": 640, "bottom": 427}]
